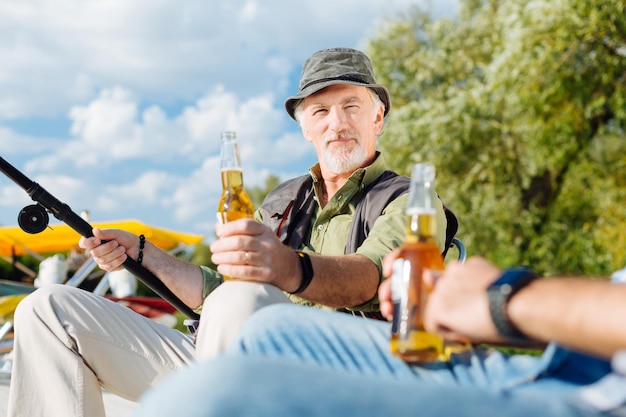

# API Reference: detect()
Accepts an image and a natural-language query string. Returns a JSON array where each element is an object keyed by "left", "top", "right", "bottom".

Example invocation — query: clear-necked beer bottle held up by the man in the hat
[{"left": 217, "top": 132, "right": 254, "bottom": 279}]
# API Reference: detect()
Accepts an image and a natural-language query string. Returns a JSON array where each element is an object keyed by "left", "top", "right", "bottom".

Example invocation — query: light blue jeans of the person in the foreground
[{"left": 138, "top": 304, "right": 610, "bottom": 417}]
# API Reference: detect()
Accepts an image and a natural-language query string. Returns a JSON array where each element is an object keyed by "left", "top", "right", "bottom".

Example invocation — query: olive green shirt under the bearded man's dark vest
[{"left": 201, "top": 154, "right": 446, "bottom": 311}]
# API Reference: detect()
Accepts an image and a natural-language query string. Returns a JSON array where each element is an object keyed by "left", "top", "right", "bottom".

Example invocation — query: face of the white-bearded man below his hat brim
[{"left": 300, "top": 84, "right": 384, "bottom": 175}]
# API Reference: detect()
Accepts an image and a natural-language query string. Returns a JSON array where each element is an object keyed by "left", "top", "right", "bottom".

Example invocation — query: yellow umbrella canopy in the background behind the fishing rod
[{"left": 0, "top": 220, "right": 204, "bottom": 256}]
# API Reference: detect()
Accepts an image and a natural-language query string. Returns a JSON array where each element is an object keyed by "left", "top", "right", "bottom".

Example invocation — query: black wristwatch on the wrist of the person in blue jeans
[{"left": 487, "top": 267, "right": 537, "bottom": 339}]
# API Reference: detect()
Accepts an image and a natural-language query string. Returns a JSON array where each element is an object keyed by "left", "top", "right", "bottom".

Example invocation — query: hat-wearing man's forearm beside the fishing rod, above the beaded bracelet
[{"left": 135, "top": 237, "right": 203, "bottom": 308}]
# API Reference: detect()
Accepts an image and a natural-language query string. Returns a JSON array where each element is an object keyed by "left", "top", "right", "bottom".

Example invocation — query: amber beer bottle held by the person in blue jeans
[{"left": 391, "top": 163, "right": 444, "bottom": 362}]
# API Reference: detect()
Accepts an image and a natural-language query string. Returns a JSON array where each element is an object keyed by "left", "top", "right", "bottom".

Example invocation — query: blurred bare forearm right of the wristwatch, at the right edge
[{"left": 507, "top": 278, "right": 626, "bottom": 357}]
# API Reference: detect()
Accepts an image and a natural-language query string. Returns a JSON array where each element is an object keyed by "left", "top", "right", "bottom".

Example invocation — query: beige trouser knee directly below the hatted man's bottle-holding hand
[{"left": 196, "top": 280, "right": 291, "bottom": 360}]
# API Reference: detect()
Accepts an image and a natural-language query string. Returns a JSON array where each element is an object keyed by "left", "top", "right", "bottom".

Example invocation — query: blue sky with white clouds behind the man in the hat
[{"left": 0, "top": 0, "right": 458, "bottom": 242}]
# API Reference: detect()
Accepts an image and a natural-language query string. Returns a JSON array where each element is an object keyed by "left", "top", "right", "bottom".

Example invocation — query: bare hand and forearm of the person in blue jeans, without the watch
[{"left": 379, "top": 254, "right": 626, "bottom": 357}]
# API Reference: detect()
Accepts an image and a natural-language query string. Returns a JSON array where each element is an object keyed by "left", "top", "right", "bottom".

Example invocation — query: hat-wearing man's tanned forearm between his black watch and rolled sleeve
[{"left": 298, "top": 254, "right": 380, "bottom": 308}]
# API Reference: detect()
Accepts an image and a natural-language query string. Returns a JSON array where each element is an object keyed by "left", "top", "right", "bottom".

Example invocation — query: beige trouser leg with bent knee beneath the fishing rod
[{"left": 8, "top": 285, "right": 195, "bottom": 417}]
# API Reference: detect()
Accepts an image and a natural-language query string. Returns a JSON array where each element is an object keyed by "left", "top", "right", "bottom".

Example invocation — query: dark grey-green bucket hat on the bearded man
[{"left": 285, "top": 48, "right": 391, "bottom": 120}]
